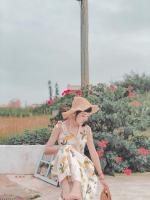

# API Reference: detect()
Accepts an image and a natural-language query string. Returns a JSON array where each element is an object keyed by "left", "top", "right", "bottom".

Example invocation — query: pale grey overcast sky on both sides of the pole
[{"left": 0, "top": 0, "right": 150, "bottom": 105}]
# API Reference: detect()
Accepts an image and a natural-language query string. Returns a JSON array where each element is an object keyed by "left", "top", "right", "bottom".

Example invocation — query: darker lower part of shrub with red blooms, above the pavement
[{"left": 92, "top": 132, "right": 150, "bottom": 175}]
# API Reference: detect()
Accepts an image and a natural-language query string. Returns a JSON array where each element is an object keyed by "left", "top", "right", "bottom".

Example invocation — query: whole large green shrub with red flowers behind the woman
[{"left": 46, "top": 80, "right": 150, "bottom": 175}]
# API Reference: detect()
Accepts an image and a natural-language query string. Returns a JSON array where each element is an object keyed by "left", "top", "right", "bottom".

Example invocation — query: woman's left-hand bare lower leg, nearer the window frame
[{"left": 60, "top": 177, "right": 71, "bottom": 200}]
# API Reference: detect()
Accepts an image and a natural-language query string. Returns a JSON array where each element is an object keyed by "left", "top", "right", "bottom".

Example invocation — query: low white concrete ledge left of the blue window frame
[{"left": 0, "top": 145, "right": 45, "bottom": 174}]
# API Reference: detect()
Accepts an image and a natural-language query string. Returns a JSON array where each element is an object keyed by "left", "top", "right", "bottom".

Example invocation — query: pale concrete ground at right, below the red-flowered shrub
[{"left": 107, "top": 173, "right": 150, "bottom": 200}]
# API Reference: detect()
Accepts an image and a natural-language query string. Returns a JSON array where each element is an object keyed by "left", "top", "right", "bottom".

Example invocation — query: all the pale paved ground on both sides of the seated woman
[{"left": 0, "top": 173, "right": 150, "bottom": 200}]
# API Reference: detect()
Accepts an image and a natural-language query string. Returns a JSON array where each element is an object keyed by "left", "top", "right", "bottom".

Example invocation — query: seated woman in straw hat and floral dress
[{"left": 45, "top": 97, "right": 108, "bottom": 200}]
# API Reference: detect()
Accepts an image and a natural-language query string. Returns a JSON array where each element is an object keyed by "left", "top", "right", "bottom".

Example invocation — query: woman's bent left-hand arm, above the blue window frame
[{"left": 44, "top": 122, "right": 61, "bottom": 154}]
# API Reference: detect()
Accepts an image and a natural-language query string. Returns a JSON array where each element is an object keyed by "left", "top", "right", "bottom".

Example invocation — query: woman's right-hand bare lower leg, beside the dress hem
[{"left": 69, "top": 181, "right": 82, "bottom": 200}]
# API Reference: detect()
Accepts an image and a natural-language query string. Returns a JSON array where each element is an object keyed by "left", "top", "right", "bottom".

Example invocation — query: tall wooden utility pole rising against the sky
[{"left": 77, "top": 0, "right": 89, "bottom": 87}]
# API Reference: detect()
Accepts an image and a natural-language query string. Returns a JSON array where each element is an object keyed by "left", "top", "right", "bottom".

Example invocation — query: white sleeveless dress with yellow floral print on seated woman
[{"left": 51, "top": 121, "right": 98, "bottom": 200}]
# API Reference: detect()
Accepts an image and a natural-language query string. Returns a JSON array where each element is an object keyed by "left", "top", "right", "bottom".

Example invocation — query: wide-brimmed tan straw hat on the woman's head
[{"left": 62, "top": 96, "right": 100, "bottom": 119}]
